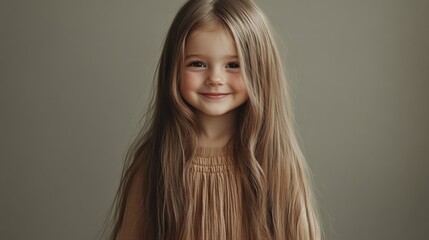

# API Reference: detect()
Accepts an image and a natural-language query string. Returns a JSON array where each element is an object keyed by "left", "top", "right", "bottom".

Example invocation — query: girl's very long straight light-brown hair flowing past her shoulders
[{"left": 99, "top": 0, "right": 321, "bottom": 240}]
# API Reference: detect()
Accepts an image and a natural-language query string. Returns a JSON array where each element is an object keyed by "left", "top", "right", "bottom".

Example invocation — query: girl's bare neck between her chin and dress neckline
[{"left": 197, "top": 111, "right": 236, "bottom": 148}]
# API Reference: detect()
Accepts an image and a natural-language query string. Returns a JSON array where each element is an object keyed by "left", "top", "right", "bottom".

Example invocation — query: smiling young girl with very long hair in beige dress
[{"left": 103, "top": 0, "right": 321, "bottom": 240}]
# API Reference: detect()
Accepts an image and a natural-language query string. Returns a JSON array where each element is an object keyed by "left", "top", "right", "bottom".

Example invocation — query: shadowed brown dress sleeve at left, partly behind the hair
[{"left": 119, "top": 171, "right": 143, "bottom": 240}]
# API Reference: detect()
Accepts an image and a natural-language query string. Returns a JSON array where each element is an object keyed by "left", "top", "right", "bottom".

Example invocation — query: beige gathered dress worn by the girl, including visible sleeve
[{"left": 120, "top": 145, "right": 247, "bottom": 240}]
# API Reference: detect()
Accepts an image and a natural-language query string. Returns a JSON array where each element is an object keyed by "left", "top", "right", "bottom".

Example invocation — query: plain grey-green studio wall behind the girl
[{"left": 0, "top": 0, "right": 429, "bottom": 240}]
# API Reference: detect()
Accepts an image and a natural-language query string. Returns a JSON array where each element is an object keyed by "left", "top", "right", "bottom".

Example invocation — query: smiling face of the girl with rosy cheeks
[{"left": 180, "top": 24, "right": 248, "bottom": 117}]
